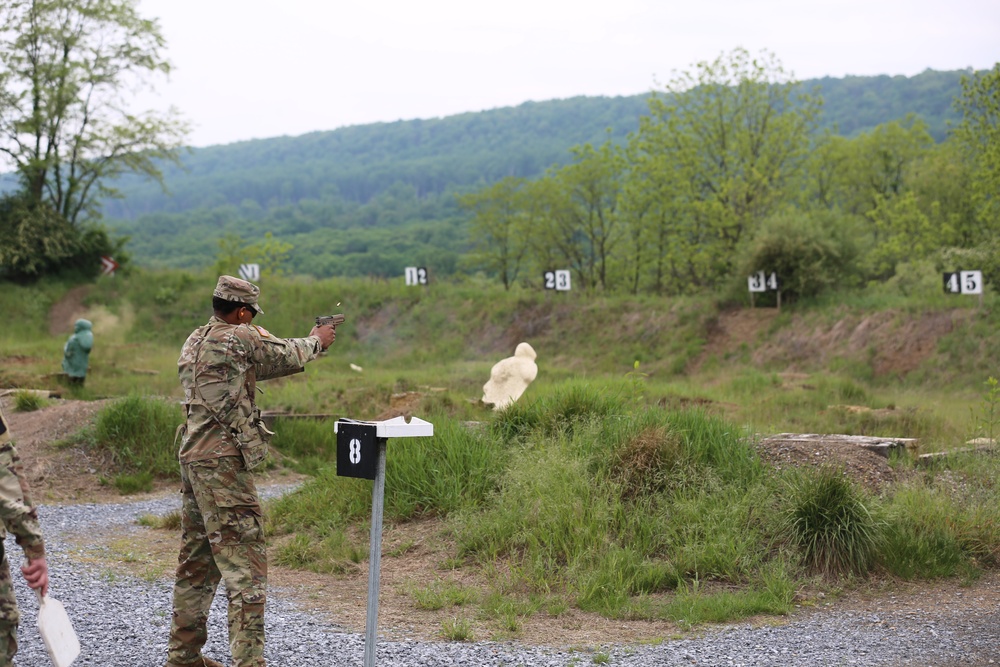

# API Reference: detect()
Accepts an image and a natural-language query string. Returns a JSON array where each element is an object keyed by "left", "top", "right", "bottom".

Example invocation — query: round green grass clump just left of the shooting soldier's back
[{"left": 94, "top": 394, "right": 184, "bottom": 477}]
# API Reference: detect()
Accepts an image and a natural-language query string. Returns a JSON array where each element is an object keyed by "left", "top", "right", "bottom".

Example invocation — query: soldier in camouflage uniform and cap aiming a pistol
[{"left": 167, "top": 276, "right": 336, "bottom": 667}]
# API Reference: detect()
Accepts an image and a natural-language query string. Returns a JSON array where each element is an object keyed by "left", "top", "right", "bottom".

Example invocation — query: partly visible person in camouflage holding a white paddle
[{"left": 0, "top": 400, "right": 49, "bottom": 667}]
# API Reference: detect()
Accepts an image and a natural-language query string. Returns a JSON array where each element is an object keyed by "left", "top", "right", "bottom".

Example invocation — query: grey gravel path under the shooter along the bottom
[{"left": 7, "top": 496, "right": 1000, "bottom": 667}]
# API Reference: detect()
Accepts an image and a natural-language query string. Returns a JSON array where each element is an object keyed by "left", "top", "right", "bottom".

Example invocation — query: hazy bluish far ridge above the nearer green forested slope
[{"left": 105, "top": 70, "right": 963, "bottom": 218}]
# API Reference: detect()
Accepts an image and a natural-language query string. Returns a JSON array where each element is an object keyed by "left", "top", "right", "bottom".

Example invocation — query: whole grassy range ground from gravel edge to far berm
[{"left": 0, "top": 272, "right": 1000, "bottom": 632}]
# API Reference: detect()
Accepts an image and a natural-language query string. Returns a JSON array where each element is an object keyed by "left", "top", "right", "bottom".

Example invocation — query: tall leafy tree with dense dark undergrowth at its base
[{"left": 0, "top": 0, "right": 186, "bottom": 279}]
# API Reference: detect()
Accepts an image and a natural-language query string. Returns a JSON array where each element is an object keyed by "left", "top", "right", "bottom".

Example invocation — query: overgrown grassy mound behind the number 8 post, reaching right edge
[{"left": 269, "top": 382, "right": 1000, "bottom": 624}]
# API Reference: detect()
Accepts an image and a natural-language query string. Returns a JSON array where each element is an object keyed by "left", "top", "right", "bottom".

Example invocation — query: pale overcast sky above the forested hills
[{"left": 136, "top": 0, "right": 1000, "bottom": 146}]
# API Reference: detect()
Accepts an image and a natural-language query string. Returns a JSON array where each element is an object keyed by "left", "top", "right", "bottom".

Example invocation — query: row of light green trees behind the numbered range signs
[{"left": 460, "top": 49, "right": 1000, "bottom": 296}]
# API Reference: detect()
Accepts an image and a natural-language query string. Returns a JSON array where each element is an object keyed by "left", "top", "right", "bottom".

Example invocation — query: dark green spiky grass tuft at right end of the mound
[{"left": 784, "top": 467, "right": 884, "bottom": 576}]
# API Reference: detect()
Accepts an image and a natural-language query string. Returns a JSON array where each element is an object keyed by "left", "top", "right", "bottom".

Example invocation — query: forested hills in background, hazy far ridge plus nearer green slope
[{"left": 104, "top": 70, "right": 966, "bottom": 276}]
